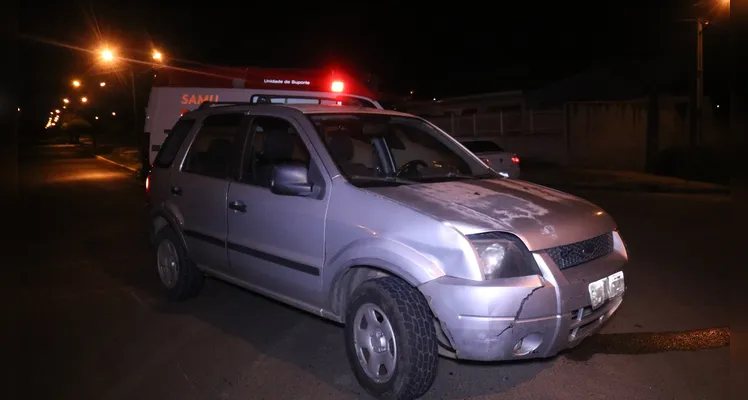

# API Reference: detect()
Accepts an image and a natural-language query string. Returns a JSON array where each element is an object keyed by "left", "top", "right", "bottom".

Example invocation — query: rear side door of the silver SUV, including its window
[{"left": 168, "top": 113, "right": 244, "bottom": 271}]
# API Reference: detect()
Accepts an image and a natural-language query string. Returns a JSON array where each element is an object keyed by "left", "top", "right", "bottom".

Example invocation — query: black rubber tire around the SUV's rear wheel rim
[{"left": 154, "top": 227, "right": 205, "bottom": 301}]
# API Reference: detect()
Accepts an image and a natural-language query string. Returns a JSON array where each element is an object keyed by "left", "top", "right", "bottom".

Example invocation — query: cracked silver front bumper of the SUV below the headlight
[{"left": 419, "top": 245, "right": 627, "bottom": 361}]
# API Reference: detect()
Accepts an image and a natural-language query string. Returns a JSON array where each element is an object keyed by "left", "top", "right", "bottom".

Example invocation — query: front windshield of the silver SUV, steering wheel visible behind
[{"left": 310, "top": 113, "right": 498, "bottom": 186}]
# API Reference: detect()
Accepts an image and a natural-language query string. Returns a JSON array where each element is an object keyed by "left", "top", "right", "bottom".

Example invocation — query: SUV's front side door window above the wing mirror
[{"left": 242, "top": 117, "right": 309, "bottom": 187}]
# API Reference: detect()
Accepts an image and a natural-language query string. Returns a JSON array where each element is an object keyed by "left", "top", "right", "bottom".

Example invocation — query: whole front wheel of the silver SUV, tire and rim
[{"left": 345, "top": 277, "right": 438, "bottom": 399}]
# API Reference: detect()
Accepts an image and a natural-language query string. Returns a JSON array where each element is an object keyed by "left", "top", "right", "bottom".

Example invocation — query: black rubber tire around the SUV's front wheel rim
[{"left": 345, "top": 277, "right": 439, "bottom": 400}]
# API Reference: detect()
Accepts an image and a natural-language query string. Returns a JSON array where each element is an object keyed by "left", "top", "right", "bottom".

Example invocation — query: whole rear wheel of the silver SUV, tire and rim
[{"left": 155, "top": 227, "right": 205, "bottom": 300}]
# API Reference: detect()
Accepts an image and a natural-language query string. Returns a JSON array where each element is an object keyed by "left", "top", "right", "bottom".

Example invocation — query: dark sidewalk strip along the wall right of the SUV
[{"left": 520, "top": 166, "right": 730, "bottom": 194}]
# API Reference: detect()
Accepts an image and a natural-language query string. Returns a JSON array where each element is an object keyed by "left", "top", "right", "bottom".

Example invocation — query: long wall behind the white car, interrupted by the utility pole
[{"left": 420, "top": 96, "right": 708, "bottom": 171}]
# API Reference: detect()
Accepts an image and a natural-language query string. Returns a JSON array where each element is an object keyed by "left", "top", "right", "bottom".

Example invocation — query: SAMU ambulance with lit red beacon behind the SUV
[{"left": 144, "top": 67, "right": 382, "bottom": 164}]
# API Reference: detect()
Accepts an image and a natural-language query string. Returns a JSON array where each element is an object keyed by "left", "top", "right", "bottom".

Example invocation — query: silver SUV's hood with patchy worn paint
[{"left": 366, "top": 179, "right": 616, "bottom": 251}]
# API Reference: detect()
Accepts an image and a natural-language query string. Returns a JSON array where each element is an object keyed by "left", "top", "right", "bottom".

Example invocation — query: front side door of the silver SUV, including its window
[{"left": 222, "top": 112, "right": 329, "bottom": 304}]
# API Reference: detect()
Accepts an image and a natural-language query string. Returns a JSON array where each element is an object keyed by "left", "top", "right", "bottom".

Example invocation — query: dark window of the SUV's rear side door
[{"left": 182, "top": 114, "right": 244, "bottom": 178}]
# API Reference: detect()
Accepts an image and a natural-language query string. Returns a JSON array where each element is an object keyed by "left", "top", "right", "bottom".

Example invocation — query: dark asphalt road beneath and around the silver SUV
[{"left": 5, "top": 146, "right": 730, "bottom": 400}]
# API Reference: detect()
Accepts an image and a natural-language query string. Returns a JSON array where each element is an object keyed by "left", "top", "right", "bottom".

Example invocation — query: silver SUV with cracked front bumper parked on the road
[{"left": 146, "top": 103, "right": 627, "bottom": 399}]
